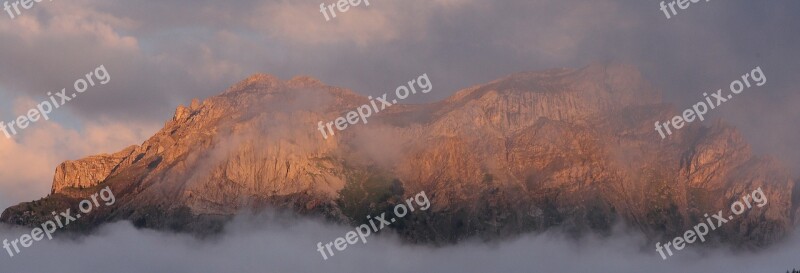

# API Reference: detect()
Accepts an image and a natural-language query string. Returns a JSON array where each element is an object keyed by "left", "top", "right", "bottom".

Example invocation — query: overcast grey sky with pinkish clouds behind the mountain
[{"left": 0, "top": 0, "right": 800, "bottom": 268}]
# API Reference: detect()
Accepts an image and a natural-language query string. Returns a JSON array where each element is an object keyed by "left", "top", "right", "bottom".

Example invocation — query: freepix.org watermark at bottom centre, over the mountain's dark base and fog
[{"left": 317, "top": 191, "right": 431, "bottom": 260}]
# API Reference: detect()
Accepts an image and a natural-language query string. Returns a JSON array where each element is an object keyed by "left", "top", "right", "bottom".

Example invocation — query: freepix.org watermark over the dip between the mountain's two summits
[{"left": 317, "top": 73, "right": 433, "bottom": 139}]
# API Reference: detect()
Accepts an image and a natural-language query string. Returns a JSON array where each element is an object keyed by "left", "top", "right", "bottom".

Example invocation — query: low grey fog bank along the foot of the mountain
[{"left": 0, "top": 214, "right": 800, "bottom": 273}]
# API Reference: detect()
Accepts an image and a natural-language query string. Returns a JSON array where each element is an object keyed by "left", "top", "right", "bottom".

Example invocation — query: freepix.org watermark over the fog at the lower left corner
[{"left": 3, "top": 186, "right": 116, "bottom": 257}]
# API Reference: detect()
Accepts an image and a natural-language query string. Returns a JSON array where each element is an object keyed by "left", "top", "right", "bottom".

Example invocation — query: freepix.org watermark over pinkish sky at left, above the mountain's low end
[{"left": 0, "top": 65, "right": 111, "bottom": 138}]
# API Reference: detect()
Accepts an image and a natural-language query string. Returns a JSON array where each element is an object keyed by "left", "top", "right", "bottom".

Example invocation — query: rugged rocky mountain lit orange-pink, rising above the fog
[{"left": 0, "top": 64, "right": 798, "bottom": 246}]
